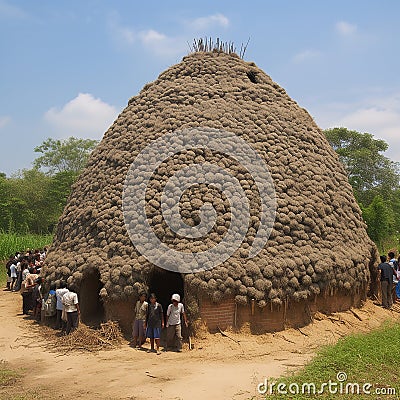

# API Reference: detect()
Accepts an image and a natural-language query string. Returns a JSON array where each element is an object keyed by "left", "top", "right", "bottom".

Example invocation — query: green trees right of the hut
[{"left": 324, "top": 128, "right": 400, "bottom": 250}]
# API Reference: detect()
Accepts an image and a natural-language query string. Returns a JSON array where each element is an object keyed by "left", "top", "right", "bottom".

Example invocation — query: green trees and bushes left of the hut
[{"left": 0, "top": 137, "right": 97, "bottom": 233}]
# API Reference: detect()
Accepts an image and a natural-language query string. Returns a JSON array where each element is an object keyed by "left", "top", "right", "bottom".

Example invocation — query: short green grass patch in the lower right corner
[{"left": 260, "top": 323, "right": 400, "bottom": 400}]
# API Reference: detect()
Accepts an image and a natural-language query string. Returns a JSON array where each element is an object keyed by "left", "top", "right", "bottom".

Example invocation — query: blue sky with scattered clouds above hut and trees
[{"left": 0, "top": 0, "right": 400, "bottom": 175}]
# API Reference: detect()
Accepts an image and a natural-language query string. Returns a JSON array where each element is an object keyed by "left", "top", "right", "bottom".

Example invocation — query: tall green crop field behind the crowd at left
[{"left": 0, "top": 233, "right": 53, "bottom": 284}]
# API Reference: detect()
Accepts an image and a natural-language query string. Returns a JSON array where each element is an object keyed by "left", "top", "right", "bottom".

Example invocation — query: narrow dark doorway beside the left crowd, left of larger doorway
[{"left": 79, "top": 270, "right": 104, "bottom": 327}]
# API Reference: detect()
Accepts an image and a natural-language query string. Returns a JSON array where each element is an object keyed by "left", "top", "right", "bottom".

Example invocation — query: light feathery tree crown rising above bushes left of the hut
[{"left": 33, "top": 137, "right": 98, "bottom": 175}]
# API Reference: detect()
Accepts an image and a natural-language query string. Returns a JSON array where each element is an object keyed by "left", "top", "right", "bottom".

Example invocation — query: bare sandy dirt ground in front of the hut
[{"left": 0, "top": 291, "right": 400, "bottom": 400}]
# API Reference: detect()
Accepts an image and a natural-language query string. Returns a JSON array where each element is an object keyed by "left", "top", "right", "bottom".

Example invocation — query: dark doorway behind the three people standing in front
[{"left": 149, "top": 267, "right": 184, "bottom": 322}]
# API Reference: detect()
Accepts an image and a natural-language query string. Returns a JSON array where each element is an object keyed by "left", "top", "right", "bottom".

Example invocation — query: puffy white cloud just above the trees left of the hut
[{"left": 44, "top": 93, "right": 118, "bottom": 139}]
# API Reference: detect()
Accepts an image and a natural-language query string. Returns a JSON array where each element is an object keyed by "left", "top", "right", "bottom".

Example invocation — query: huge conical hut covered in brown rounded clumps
[{"left": 44, "top": 47, "right": 377, "bottom": 332}]
